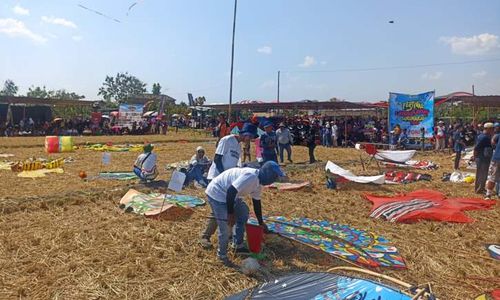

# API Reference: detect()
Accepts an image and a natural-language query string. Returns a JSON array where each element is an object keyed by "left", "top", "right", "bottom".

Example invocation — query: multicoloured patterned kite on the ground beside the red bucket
[{"left": 250, "top": 216, "right": 406, "bottom": 269}]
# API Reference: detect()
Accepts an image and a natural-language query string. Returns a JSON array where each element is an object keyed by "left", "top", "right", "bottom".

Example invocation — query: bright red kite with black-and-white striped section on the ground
[{"left": 365, "top": 190, "right": 496, "bottom": 223}]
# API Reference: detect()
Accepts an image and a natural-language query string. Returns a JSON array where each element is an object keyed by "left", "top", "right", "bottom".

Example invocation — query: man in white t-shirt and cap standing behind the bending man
[{"left": 200, "top": 123, "right": 257, "bottom": 248}]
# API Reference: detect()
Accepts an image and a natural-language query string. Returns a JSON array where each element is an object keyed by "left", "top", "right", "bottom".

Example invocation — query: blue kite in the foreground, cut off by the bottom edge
[{"left": 226, "top": 273, "right": 411, "bottom": 300}]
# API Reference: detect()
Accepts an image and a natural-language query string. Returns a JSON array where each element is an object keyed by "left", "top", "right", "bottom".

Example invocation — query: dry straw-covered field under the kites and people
[{"left": 0, "top": 132, "right": 500, "bottom": 300}]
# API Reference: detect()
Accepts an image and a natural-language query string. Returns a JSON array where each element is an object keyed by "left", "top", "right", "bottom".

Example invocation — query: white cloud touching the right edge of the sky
[{"left": 439, "top": 33, "right": 500, "bottom": 55}]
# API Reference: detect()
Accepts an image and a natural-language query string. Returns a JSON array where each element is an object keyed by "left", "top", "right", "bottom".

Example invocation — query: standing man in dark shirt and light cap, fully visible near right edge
[{"left": 473, "top": 122, "right": 494, "bottom": 194}]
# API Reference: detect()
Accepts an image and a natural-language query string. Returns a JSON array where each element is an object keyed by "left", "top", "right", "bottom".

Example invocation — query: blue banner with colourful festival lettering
[{"left": 389, "top": 92, "right": 434, "bottom": 138}]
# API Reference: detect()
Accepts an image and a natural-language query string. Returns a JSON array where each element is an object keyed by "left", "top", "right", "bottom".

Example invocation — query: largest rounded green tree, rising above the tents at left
[{"left": 98, "top": 73, "right": 146, "bottom": 103}]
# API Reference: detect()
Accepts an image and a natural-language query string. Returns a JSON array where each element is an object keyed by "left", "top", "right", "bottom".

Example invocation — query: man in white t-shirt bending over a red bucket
[{"left": 205, "top": 161, "right": 285, "bottom": 266}]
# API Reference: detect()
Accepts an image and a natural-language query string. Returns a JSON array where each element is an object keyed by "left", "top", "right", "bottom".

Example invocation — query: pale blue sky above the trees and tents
[{"left": 0, "top": 0, "right": 500, "bottom": 103}]
